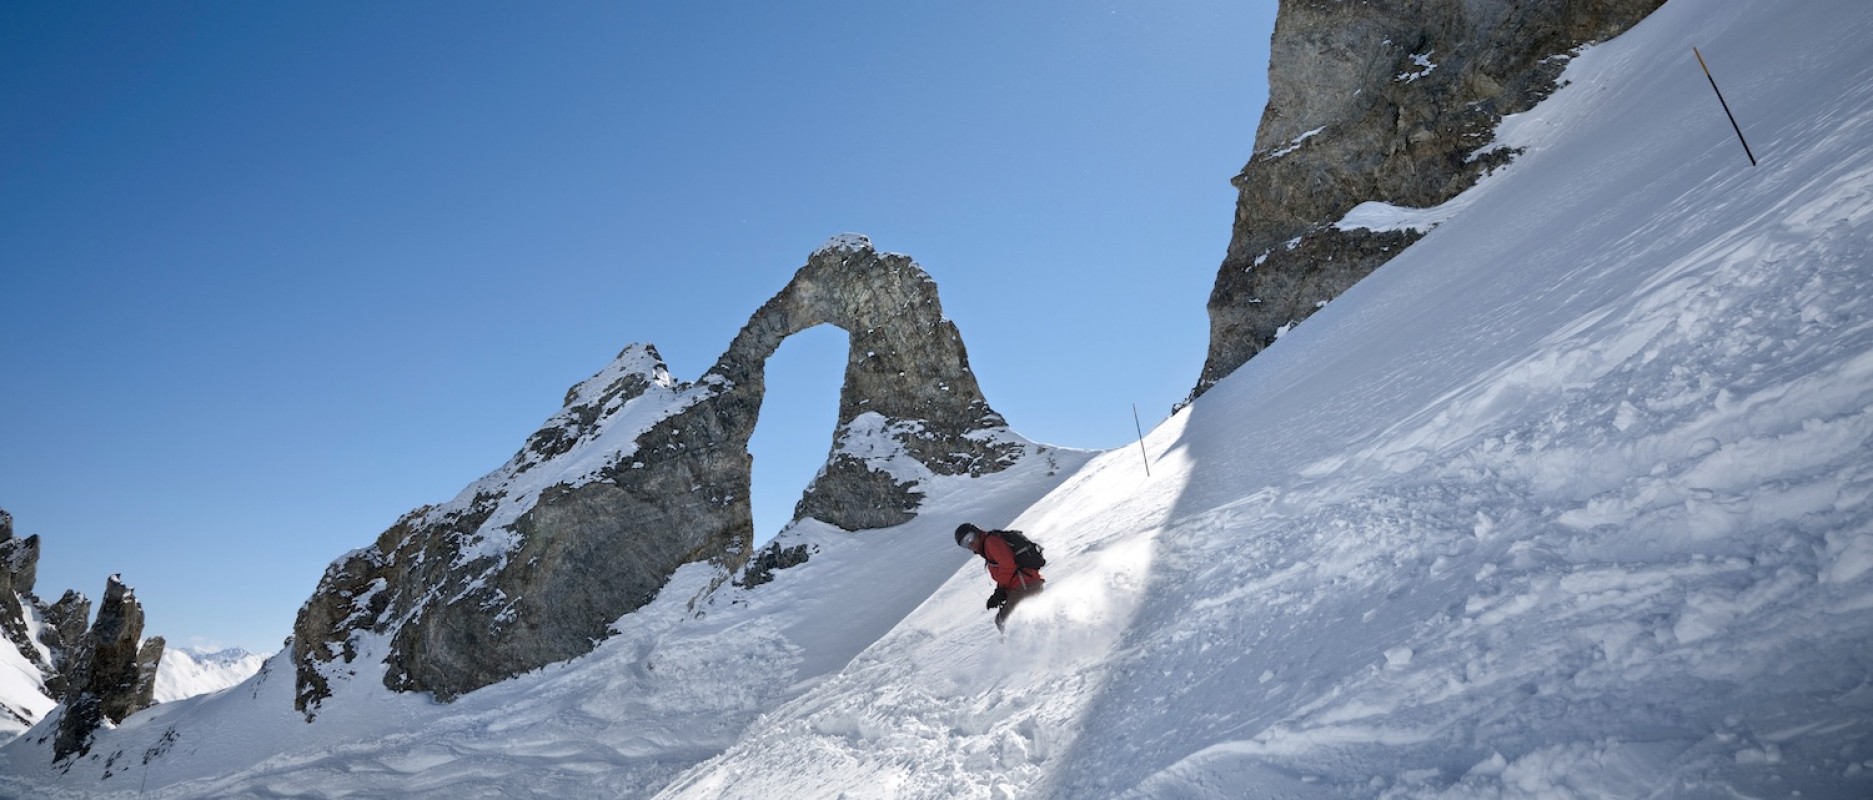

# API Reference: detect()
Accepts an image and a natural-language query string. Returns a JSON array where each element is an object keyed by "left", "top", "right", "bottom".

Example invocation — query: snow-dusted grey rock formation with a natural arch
[{"left": 294, "top": 236, "right": 1025, "bottom": 718}]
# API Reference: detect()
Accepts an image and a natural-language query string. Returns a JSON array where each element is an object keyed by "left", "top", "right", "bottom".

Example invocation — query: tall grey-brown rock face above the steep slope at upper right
[{"left": 1195, "top": 0, "right": 1663, "bottom": 393}]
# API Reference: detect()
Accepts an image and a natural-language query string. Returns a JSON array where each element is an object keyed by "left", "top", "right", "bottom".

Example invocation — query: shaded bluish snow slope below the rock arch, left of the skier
[{"left": 0, "top": 444, "right": 1090, "bottom": 798}]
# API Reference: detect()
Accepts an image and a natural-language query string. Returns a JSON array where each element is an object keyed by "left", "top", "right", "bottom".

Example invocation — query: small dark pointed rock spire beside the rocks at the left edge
[{"left": 52, "top": 575, "right": 163, "bottom": 761}]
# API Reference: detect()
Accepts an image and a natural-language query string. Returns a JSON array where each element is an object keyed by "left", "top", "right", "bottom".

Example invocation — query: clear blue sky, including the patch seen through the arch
[{"left": 0, "top": 0, "right": 1274, "bottom": 652}]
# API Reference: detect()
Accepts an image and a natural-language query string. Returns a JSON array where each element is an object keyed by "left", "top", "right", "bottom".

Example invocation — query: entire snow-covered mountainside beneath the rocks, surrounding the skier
[{"left": 0, "top": 0, "right": 1873, "bottom": 798}]
